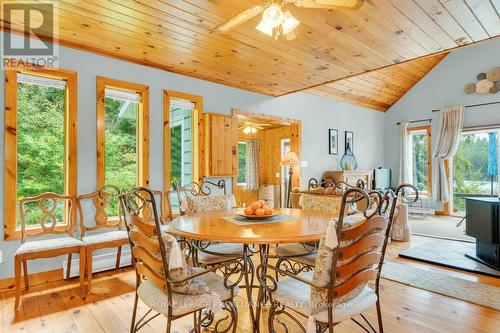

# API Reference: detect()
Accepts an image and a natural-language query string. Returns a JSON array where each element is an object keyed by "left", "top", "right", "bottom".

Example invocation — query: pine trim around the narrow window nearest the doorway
[{"left": 163, "top": 89, "right": 204, "bottom": 193}]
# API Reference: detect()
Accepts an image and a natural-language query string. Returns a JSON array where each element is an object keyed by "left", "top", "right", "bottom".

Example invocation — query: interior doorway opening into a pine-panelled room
[{"left": 233, "top": 110, "right": 301, "bottom": 208}]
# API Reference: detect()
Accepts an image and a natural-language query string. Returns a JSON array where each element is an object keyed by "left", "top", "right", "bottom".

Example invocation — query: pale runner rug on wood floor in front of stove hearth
[{"left": 382, "top": 261, "right": 500, "bottom": 311}]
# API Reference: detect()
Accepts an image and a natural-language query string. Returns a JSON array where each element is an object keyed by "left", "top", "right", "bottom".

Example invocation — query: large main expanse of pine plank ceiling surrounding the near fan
[{"left": 3, "top": 0, "right": 500, "bottom": 109}]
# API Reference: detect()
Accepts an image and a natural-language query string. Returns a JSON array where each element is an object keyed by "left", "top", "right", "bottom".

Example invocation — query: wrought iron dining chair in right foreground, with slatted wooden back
[{"left": 257, "top": 184, "right": 415, "bottom": 333}]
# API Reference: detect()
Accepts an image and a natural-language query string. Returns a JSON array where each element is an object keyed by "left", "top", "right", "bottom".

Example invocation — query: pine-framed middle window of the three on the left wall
[{"left": 97, "top": 77, "right": 149, "bottom": 192}]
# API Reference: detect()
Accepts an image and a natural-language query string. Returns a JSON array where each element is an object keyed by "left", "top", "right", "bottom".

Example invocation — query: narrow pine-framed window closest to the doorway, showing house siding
[{"left": 163, "top": 90, "right": 203, "bottom": 191}]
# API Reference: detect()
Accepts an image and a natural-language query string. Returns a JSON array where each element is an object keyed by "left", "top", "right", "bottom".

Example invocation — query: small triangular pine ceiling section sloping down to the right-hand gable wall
[{"left": 306, "top": 53, "right": 447, "bottom": 112}]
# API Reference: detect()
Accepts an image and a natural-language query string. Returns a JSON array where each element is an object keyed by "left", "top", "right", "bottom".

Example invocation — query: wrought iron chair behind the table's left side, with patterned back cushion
[{"left": 169, "top": 179, "right": 246, "bottom": 271}]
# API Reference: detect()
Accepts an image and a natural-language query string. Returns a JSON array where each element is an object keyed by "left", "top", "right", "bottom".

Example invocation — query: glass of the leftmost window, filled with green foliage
[{"left": 17, "top": 82, "right": 65, "bottom": 225}]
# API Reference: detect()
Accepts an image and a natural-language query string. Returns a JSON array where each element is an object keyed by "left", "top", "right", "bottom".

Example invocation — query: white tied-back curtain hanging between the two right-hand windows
[{"left": 432, "top": 106, "right": 464, "bottom": 203}]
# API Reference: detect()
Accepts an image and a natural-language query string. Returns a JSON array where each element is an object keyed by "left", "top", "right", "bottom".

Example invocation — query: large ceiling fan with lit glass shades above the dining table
[{"left": 215, "top": 0, "right": 364, "bottom": 40}]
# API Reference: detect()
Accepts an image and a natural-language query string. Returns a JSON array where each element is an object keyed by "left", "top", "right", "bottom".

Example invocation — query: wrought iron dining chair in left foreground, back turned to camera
[{"left": 120, "top": 187, "right": 242, "bottom": 333}]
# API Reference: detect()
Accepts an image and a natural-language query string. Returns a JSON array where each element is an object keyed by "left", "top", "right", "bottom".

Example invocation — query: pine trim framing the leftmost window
[{"left": 4, "top": 65, "right": 78, "bottom": 240}]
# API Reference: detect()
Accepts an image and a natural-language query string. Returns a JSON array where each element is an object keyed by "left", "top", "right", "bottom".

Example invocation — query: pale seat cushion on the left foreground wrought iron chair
[{"left": 137, "top": 272, "right": 239, "bottom": 316}]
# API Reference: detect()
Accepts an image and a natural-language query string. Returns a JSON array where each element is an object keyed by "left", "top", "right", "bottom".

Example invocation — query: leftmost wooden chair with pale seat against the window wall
[{"left": 14, "top": 192, "right": 85, "bottom": 309}]
